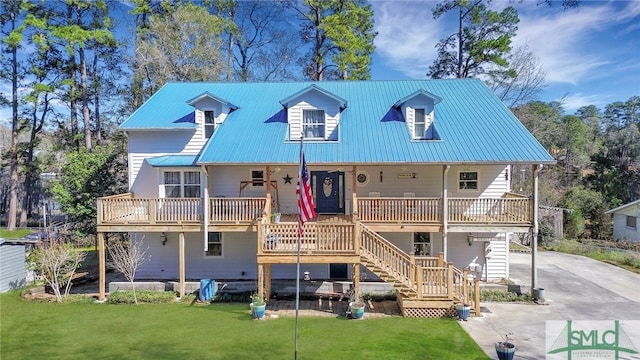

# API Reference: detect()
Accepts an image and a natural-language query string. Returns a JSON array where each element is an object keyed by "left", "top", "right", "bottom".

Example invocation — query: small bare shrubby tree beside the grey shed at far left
[{"left": 29, "top": 236, "right": 85, "bottom": 302}]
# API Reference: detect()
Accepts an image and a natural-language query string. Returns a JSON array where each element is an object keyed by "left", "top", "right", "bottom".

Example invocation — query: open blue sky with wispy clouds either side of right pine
[{"left": 371, "top": 0, "right": 640, "bottom": 113}]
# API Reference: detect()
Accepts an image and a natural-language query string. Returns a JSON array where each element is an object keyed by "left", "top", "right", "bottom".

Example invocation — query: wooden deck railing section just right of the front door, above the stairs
[{"left": 358, "top": 197, "right": 442, "bottom": 223}]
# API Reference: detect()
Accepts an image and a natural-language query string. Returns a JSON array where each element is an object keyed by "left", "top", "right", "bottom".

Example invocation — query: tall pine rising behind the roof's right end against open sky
[{"left": 427, "top": 0, "right": 520, "bottom": 79}]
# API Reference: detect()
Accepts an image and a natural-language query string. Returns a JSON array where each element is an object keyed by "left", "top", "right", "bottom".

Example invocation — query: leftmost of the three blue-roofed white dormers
[{"left": 187, "top": 91, "right": 238, "bottom": 139}]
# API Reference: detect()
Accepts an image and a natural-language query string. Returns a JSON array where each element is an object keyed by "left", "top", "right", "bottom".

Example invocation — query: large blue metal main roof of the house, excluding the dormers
[{"left": 120, "top": 79, "right": 554, "bottom": 164}]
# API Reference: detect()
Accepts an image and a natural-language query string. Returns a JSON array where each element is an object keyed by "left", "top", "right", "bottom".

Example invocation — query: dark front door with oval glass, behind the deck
[{"left": 311, "top": 171, "right": 344, "bottom": 214}]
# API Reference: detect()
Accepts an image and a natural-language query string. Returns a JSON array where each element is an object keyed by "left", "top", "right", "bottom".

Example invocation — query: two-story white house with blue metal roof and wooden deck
[{"left": 98, "top": 79, "right": 554, "bottom": 315}]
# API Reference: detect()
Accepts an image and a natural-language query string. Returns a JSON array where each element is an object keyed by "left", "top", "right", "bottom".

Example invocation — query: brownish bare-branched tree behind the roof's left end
[{"left": 135, "top": 3, "right": 228, "bottom": 98}]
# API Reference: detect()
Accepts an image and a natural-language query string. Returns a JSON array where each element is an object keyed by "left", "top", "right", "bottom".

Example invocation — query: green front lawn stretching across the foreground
[{"left": 0, "top": 292, "right": 487, "bottom": 360}]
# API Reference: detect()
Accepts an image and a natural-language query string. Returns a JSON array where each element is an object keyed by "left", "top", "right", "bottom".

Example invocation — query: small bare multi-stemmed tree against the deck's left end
[{"left": 109, "top": 240, "right": 150, "bottom": 304}]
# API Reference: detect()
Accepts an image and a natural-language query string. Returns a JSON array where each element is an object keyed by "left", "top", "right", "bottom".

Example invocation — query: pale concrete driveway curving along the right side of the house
[{"left": 461, "top": 251, "right": 640, "bottom": 359}]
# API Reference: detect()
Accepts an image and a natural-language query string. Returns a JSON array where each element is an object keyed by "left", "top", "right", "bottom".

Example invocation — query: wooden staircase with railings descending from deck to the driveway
[{"left": 358, "top": 223, "right": 480, "bottom": 317}]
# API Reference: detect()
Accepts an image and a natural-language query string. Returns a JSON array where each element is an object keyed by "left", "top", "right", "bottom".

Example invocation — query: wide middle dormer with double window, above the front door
[{"left": 280, "top": 84, "right": 347, "bottom": 140}]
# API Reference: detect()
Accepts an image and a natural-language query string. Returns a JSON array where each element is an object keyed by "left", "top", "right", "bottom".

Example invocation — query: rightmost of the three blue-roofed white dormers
[{"left": 393, "top": 89, "right": 442, "bottom": 140}]
